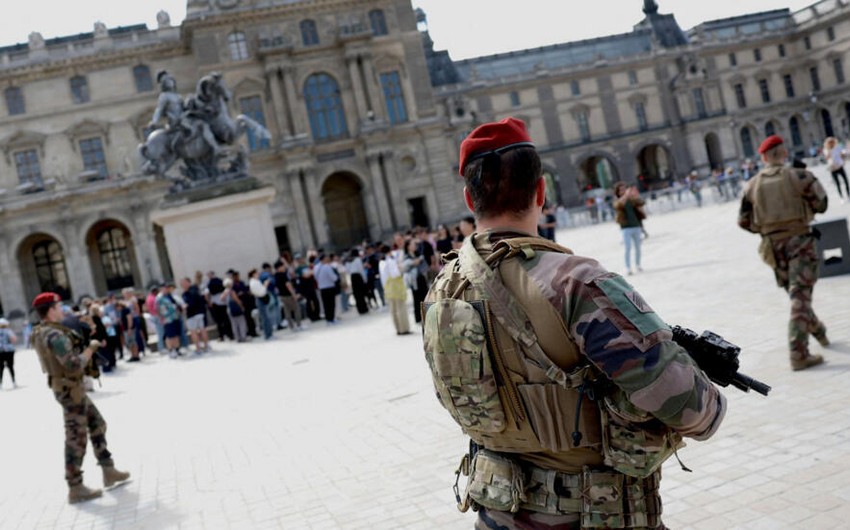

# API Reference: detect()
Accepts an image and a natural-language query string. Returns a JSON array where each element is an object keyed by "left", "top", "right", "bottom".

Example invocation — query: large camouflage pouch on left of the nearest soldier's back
[{"left": 423, "top": 298, "right": 506, "bottom": 433}]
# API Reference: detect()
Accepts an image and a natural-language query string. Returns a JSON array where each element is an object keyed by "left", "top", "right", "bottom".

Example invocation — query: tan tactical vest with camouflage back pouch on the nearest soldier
[{"left": 422, "top": 237, "right": 603, "bottom": 473}]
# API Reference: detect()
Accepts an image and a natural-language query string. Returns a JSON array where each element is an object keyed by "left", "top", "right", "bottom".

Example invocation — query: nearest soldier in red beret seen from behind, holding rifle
[{"left": 423, "top": 118, "right": 726, "bottom": 530}]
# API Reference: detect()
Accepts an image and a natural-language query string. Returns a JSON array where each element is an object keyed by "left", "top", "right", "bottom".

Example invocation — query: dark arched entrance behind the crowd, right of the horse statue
[{"left": 322, "top": 173, "right": 369, "bottom": 248}]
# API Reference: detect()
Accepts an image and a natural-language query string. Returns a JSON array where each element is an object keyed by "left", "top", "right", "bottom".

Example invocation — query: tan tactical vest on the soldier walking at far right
[{"left": 747, "top": 166, "right": 814, "bottom": 237}]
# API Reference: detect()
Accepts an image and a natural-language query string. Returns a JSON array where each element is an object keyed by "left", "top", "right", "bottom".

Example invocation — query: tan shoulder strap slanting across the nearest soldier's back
[{"left": 452, "top": 237, "right": 584, "bottom": 388}]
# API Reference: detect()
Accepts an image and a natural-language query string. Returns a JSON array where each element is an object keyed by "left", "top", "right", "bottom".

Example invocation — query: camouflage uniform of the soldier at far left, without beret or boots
[{"left": 32, "top": 323, "right": 114, "bottom": 486}]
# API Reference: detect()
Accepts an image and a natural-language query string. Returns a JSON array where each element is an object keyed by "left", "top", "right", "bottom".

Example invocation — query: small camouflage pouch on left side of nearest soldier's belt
[{"left": 466, "top": 449, "right": 525, "bottom": 512}]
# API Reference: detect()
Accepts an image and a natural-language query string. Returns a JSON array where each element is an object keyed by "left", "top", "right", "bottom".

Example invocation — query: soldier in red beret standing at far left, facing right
[{"left": 32, "top": 293, "right": 130, "bottom": 504}]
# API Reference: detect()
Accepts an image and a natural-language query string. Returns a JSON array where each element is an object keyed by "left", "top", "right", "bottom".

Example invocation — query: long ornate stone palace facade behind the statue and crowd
[{"left": 0, "top": 0, "right": 850, "bottom": 314}]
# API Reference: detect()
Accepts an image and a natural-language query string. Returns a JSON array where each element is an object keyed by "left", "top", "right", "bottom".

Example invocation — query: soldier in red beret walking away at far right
[{"left": 738, "top": 135, "right": 829, "bottom": 371}]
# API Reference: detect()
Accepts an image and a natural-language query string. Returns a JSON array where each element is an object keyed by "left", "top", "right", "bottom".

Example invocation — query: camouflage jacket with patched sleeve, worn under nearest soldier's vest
[{"left": 425, "top": 231, "right": 726, "bottom": 463}]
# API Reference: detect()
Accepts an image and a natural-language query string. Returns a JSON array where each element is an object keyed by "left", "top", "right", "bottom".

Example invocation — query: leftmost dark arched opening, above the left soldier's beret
[{"left": 18, "top": 233, "right": 72, "bottom": 300}]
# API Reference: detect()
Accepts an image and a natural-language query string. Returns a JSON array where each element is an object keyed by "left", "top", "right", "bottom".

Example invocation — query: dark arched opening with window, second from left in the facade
[{"left": 86, "top": 219, "right": 142, "bottom": 293}]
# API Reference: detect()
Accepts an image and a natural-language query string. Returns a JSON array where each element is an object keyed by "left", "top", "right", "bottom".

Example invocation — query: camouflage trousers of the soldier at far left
[{"left": 53, "top": 387, "right": 113, "bottom": 486}]
